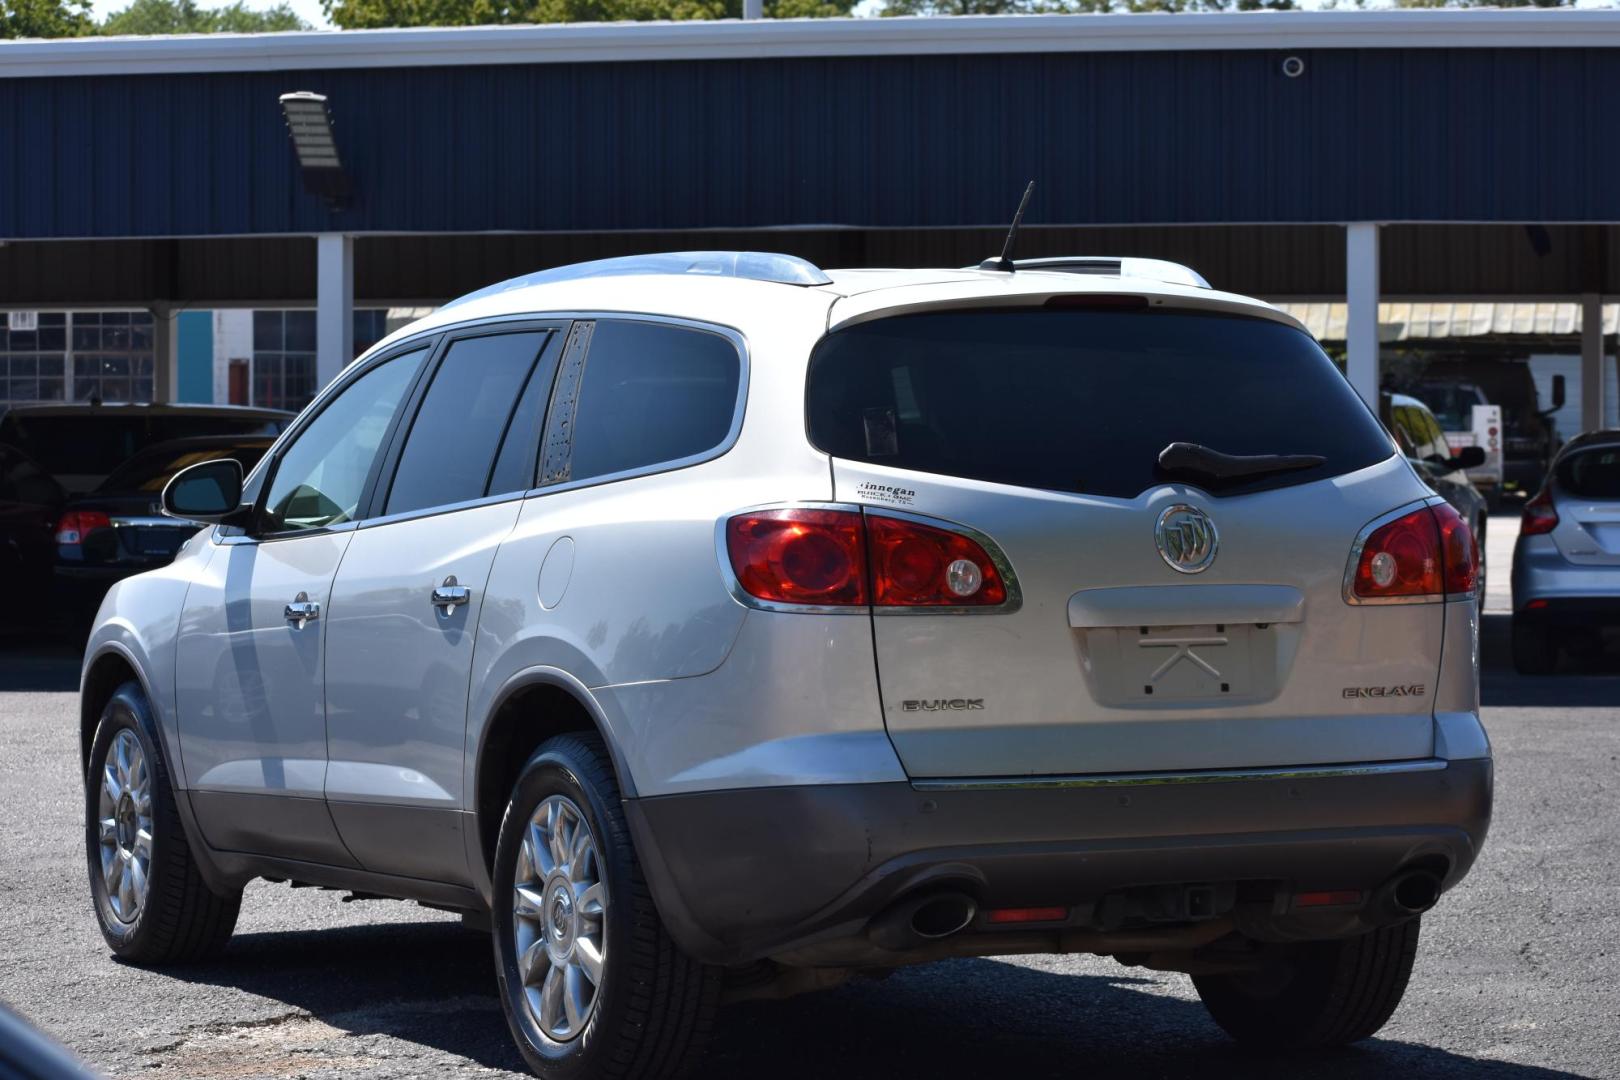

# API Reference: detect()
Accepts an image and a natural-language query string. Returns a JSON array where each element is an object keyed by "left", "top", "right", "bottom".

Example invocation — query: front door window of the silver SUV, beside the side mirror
[{"left": 262, "top": 348, "right": 428, "bottom": 533}]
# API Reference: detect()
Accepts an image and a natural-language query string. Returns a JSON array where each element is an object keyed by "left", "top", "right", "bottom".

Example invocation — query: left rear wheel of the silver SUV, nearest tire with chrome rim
[{"left": 491, "top": 733, "right": 721, "bottom": 1080}]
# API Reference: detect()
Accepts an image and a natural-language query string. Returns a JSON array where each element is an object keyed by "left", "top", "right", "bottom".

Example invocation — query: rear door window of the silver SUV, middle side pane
[{"left": 384, "top": 330, "right": 548, "bottom": 513}]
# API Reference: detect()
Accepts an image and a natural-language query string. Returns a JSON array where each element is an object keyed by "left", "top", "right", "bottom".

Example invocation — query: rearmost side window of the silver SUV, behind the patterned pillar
[{"left": 570, "top": 321, "right": 742, "bottom": 479}]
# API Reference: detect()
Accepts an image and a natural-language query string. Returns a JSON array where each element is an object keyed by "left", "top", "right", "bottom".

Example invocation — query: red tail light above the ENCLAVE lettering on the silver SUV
[{"left": 1349, "top": 502, "right": 1479, "bottom": 602}]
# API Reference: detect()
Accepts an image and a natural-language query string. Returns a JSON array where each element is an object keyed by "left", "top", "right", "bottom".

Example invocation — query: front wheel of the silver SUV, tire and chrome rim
[{"left": 84, "top": 682, "right": 241, "bottom": 965}]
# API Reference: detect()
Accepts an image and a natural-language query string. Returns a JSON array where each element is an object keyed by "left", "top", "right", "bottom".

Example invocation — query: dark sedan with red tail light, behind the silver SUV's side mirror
[{"left": 53, "top": 436, "right": 274, "bottom": 620}]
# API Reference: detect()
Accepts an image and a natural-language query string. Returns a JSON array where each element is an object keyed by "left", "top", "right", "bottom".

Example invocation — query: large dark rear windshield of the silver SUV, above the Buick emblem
[{"left": 808, "top": 309, "right": 1395, "bottom": 499}]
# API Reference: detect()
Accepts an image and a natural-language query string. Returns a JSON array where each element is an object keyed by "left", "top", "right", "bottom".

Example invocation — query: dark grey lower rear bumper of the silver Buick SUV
[{"left": 625, "top": 759, "right": 1492, "bottom": 963}]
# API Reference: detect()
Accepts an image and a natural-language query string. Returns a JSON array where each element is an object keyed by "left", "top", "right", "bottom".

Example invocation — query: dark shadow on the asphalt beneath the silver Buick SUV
[{"left": 161, "top": 923, "right": 1576, "bottom": 1080}]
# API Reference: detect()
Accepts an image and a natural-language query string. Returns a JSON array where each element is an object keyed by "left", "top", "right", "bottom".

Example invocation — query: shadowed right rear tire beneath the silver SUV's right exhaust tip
[{"left": 1192, "top": 918, "right": 1422, "bottom": 1049}]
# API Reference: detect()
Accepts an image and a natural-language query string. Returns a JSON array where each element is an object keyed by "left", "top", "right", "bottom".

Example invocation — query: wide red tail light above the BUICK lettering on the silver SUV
[{"left": 726, "top": 507, "right": 1008, "bottom": 607}]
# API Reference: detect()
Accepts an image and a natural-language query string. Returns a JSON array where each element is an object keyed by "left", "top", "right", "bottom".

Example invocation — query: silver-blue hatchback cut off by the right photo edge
[{"left": 1513, "top": 431, "right": 1620, "bottom": 675}]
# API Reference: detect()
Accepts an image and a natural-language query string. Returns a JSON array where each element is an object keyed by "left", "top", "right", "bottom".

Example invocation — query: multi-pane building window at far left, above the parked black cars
[{"left": 0, "top": 311, "right": 154, "bottom": 405}]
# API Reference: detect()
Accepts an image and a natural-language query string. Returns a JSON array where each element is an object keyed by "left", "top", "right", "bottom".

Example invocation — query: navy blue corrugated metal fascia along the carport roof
[{"left": 0, "top": 49, "right": 1620, "bottom": 238}]
